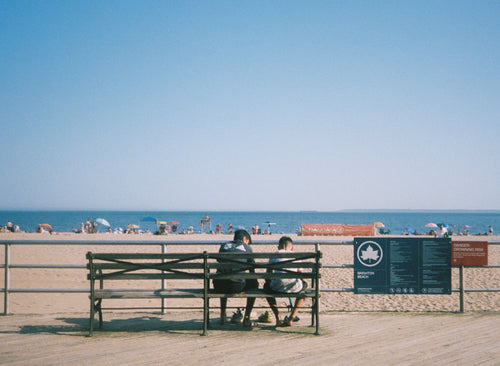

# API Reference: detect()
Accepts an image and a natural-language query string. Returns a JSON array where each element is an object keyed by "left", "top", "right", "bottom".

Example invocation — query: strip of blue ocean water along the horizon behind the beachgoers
[{"left": 0, "top": 211, "right": 500, "bottom": 234}]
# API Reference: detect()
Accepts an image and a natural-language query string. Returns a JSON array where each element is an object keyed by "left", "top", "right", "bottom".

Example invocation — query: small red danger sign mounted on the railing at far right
[{"left": 451, "top": 241, "right": 488, "bottom": 266}]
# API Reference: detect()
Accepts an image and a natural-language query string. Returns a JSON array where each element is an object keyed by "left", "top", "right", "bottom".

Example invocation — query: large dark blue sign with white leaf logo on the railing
[{"left": 354, "top": 237, "right": 451, "bottom": 294}]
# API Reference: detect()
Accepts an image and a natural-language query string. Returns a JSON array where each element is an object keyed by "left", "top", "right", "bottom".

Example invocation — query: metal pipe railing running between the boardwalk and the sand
[{"left": 0, "top": 239, "right": 500, "bottom": 315}]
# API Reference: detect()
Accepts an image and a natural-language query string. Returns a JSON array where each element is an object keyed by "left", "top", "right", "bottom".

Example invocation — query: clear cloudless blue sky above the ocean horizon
[{"left": 0, "top": 0, "right": 500, "bottom": 211}]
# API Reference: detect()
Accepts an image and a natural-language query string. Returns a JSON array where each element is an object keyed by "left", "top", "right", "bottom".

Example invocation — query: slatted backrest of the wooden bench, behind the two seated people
[{"left": 87, "top": 251, "right": 321, "bottom": 280}]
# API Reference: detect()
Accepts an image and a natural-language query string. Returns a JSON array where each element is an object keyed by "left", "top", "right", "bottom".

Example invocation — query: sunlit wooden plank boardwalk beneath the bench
[{"left": 0, "top": 311, "right": 500, "bottom": 366}]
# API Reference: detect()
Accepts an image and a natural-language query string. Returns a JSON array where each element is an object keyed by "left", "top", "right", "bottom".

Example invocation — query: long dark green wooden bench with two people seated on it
[{"left": 87, "top": 250, "right": 321, "bottom": 336}]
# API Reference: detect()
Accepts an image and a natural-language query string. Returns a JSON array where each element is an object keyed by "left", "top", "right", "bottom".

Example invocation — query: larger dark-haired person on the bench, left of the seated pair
[{"left": 213, "top": 229, "right": 259, "bottom": 327}]
